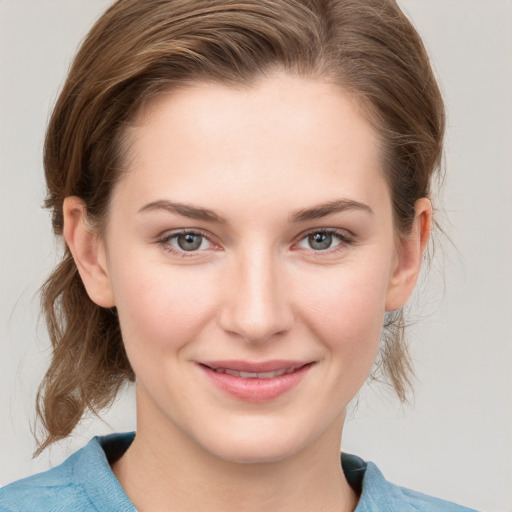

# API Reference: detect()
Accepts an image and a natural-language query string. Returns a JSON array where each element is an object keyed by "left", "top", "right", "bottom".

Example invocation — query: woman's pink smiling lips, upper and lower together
[{"left": 198, "top": 360, "right": 314, "bottom": 403}]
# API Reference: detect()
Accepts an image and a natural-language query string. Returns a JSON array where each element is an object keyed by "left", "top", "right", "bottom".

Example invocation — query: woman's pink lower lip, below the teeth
[{"left": 199, "top": 364, "right": 313, "bottom": 402}]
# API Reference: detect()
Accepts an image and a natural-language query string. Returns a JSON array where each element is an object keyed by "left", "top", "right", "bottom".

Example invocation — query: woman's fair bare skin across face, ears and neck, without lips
[{"left": 64, "top": 74, "right": 431, "bottom": 511}]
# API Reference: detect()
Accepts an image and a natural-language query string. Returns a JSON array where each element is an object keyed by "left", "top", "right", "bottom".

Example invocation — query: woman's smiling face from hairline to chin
[{"left": 69, "top": 76, "right": 428, "bottom": 462}]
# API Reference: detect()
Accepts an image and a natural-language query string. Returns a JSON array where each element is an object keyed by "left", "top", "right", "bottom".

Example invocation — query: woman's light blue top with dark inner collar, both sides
[{"left": 0, "top": 432, "right": 476, "bottom": 512}]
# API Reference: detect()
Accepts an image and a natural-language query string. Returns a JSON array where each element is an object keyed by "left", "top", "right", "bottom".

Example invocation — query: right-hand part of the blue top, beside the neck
[{"left": 342, "top": 454, "right": 477, "bottom": 512}]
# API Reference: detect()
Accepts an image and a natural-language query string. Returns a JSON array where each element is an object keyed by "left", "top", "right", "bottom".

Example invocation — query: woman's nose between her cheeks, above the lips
[{"left": 219, "top": 245, "right": 293, "bottom": 343}]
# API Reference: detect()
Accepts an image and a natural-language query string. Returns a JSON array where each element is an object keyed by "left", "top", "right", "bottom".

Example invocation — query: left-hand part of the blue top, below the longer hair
[{"left": 0, "top": 435, "right": 135, "bottom": 512}]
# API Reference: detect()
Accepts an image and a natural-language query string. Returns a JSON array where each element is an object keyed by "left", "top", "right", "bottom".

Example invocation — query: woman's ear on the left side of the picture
[{"left": 63, "top": 196, "right": 115, "bottom": 308}]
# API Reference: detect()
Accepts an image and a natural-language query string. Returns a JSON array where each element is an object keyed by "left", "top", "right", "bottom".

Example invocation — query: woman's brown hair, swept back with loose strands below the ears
[{"left": 37, "top": 0, "right": 444, "bottom": 452}]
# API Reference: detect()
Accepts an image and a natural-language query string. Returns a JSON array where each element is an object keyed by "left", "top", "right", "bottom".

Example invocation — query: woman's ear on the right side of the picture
[{"left": 386, "top": 197, "right": 432, "bottom": 311}]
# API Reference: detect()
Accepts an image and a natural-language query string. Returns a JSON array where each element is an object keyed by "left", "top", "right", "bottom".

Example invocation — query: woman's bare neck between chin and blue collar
[{"left": 112, "top": 396, "right": 357, "bottom": 512}]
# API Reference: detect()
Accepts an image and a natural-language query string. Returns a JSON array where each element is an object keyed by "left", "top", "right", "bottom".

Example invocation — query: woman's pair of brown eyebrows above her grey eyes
[{"left": 139, "top": 199, "right": 373, "bottom": 224}]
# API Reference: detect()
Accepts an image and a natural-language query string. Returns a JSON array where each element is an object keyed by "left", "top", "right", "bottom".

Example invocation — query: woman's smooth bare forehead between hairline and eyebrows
[{"left": 113, "top": 75, "right": 383, "bottom": 212}]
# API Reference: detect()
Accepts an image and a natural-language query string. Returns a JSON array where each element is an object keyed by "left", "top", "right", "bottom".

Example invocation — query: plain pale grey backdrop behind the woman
[{"left": 0, "top": 0, "right": 512, "bottom": 512}]
